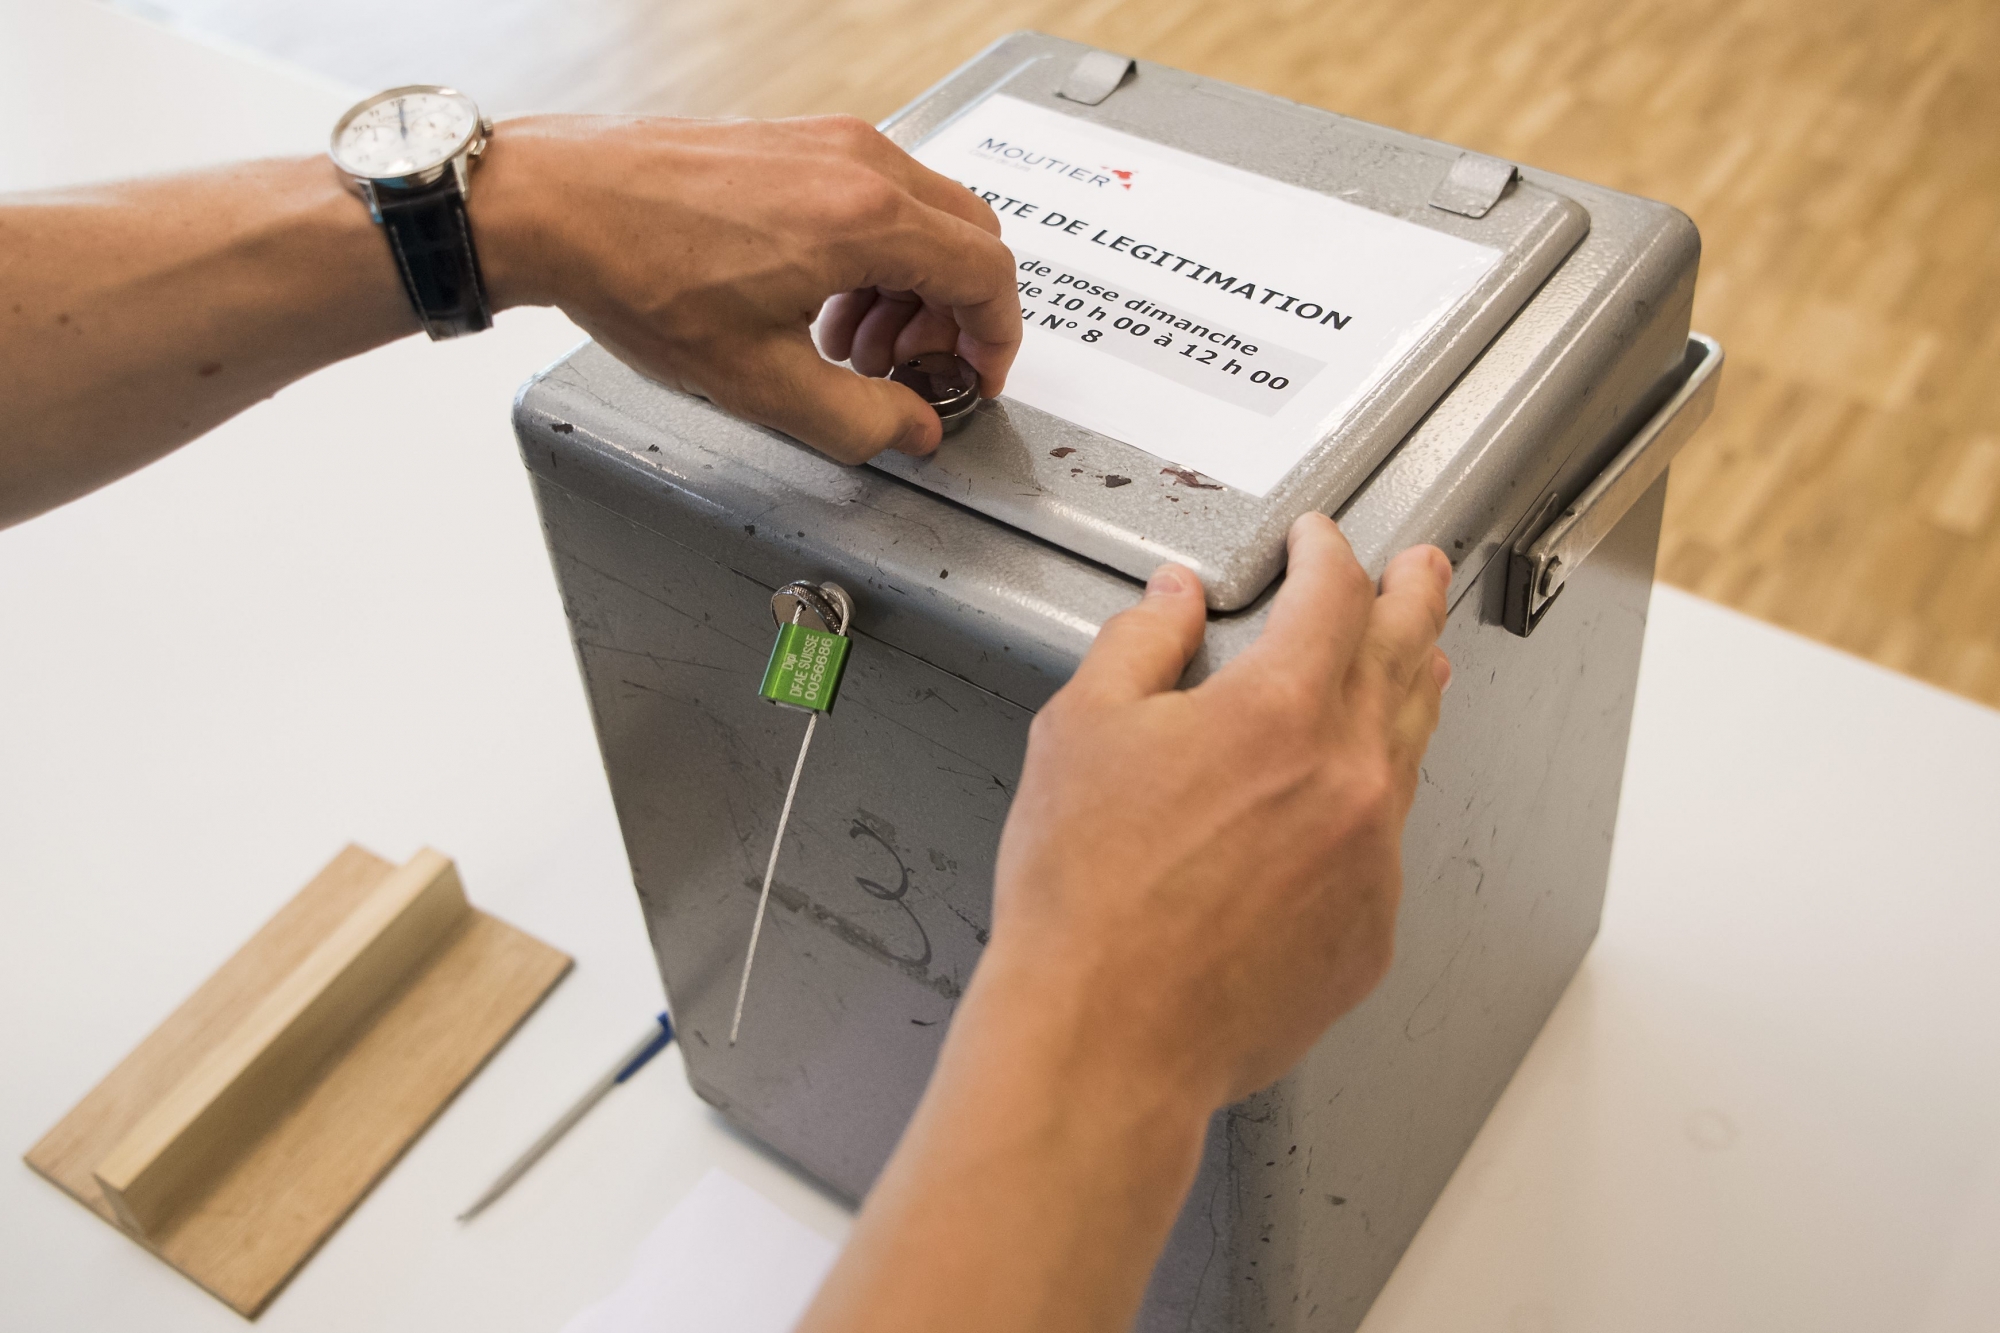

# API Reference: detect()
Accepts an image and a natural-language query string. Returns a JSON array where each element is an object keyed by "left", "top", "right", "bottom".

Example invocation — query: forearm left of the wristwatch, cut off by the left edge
[{"left": 0, "top": 158, "right": 416, "bottom": 524}]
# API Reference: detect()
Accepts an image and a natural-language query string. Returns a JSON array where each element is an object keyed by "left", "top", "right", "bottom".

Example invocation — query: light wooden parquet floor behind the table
[{"left": 130, "top": 0, "right": 2000, "bottom": 705}]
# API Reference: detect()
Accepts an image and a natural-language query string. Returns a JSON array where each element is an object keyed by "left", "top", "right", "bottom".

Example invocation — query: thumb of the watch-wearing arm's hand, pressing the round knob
[{"left": 702, "top": 332, "right": 944, "bottom": 462}]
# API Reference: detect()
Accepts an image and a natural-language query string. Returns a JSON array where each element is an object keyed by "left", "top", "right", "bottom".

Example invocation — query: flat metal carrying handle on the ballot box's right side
[{"left": 1506, "top": 334, "right": 1722, "bottom": 636}]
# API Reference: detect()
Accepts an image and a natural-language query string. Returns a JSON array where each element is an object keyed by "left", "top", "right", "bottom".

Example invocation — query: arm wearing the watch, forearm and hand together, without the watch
[{"left": 0, "top": 116, "right": 1020, "bottom": 526}]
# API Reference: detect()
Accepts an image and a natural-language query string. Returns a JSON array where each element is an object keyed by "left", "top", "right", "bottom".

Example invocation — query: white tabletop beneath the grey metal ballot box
[{"left": 0, "top": 0, "right": 2000, "bottom": 1333}]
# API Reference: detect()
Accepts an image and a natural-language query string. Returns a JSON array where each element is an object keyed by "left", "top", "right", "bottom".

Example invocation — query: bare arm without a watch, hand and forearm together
[{"left": 800, "top": 514, "right": 1450, "bottom": 1333}]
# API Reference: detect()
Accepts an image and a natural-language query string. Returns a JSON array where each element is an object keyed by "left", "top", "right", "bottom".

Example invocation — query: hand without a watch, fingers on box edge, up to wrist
[{"left": 980, "top": 514, "right": 1452, "bottom": 1109}]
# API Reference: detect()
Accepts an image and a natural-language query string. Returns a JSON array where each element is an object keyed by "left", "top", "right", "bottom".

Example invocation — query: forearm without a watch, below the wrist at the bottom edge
[{"left": 800, "top": 959, "right": 1208, "bottom": 1333}]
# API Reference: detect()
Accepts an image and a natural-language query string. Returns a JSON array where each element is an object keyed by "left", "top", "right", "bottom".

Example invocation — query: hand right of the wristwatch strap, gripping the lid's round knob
[{"left": 470, "top": 116, "right": 1020, "bottom": 462}]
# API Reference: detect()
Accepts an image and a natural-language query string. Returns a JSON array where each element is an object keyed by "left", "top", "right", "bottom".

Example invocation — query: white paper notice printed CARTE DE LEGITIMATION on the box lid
[{"left": 914, "top": 94, "right": 1500, "bottom": 494}]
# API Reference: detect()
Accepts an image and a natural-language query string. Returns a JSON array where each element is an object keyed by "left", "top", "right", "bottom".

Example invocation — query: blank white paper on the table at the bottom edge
[{"left": 562, "top": 1169, "right": 836, "bottom": 1333}]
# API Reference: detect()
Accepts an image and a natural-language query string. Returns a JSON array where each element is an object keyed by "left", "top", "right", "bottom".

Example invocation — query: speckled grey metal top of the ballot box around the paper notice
[{"left": 514, "top": 32, "right": 1700, "bottom": 688}]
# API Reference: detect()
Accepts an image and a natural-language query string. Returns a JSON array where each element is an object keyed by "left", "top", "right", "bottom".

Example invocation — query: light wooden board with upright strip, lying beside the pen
[{"left": 28, "top": 847, "right": 570, "bottom": 1315}]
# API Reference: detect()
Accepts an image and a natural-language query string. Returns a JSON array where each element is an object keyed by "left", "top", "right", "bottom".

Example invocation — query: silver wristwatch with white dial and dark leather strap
[{"left": 328, "top": 84, "right": 494, "bottom": 338}]
